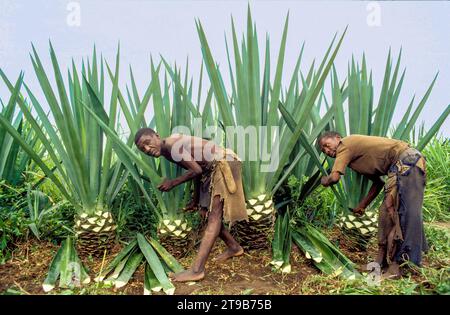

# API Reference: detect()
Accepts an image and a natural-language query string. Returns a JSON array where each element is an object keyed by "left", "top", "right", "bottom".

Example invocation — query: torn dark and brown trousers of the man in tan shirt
[{"left": 378, "top": 148, "right": 428, "bottom": 266}]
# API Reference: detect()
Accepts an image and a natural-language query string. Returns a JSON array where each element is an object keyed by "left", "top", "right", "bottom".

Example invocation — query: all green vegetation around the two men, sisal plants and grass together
[{"left": 0, "top": 6, "right": 450, "bottom": 294}]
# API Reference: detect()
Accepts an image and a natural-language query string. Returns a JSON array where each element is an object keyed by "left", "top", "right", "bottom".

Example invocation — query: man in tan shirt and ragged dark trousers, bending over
[{"left": 318, "top": 131, "right": 428, "bottom": 277}]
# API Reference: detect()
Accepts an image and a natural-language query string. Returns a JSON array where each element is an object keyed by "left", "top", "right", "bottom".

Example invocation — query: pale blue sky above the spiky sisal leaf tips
[{"left": 0, "top": 0, "right": 450, "bottom": 136}]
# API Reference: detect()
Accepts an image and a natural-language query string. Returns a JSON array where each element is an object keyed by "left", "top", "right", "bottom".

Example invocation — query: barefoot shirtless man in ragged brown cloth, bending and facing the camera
[{"left": 135, "top": 128, "right": 248, "bottom": 282}]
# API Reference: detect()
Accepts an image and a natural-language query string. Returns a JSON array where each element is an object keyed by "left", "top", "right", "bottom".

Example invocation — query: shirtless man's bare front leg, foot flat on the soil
[{"left": 171, "top": 196, "right": 223, "bottom": 282}]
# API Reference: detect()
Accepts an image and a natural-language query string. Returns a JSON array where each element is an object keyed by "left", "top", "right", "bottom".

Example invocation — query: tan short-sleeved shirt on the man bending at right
[{"left": 332, "top": 135, "right": 409, "bottom": 176}]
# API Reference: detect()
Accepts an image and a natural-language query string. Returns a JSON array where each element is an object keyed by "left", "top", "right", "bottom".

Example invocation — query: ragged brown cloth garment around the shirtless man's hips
[{"left": 199, "top": 158, "right": 248, "bottom": 227}]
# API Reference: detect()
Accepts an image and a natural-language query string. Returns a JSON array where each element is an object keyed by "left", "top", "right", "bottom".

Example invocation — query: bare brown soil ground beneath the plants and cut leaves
[{"left": 0, "top": 227, "right": 446, "bottom": 295}]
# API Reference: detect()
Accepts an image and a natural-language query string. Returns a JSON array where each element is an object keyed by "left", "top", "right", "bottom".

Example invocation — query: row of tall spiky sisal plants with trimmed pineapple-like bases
[{"left": 0, "top": 12, "right": 450, "bottom": 294}]
